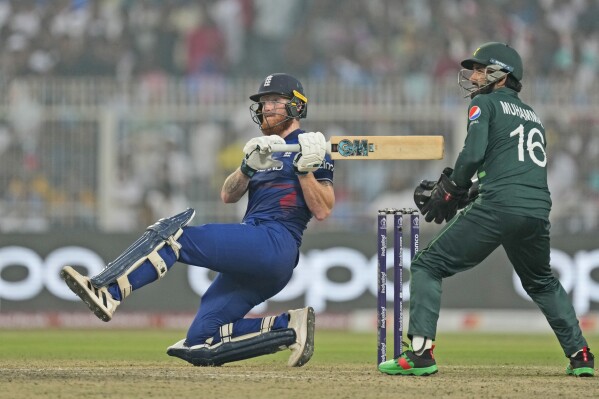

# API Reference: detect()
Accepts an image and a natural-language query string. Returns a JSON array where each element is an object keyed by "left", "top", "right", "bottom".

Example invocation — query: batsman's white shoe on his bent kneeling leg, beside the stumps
[{"left": 287, "top": 306, "right": 316, "bottom": 367}]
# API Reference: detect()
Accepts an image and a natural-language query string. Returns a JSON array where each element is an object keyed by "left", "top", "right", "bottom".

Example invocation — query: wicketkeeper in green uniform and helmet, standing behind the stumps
[{"left": 379, "top": 42, "right": 594, "bottom": 377}]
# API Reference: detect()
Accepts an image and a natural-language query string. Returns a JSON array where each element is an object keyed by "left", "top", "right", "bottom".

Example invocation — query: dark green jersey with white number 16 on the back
[{"left": 452, "top": 87, "right": 551, "bottom": 220}]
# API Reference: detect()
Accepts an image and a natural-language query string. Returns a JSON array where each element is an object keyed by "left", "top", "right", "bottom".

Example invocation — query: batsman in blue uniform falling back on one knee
[{"left": 61, "top": 73, "right": 335, "bottom": 366}]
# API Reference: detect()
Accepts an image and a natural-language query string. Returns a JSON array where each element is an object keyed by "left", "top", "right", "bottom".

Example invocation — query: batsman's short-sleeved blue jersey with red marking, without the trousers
[{"left": 243, "top": 129, "right": 335, "bottom": 247}]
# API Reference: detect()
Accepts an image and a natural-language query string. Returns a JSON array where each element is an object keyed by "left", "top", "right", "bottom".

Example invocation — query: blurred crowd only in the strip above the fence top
[{"left": 0, "top": 0, "right": 599, "bottom": 87}]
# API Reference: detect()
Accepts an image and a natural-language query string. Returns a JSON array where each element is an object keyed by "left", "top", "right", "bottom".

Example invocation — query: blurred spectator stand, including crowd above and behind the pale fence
[{"left": 0, "top": 0, "right": 599, "bottom": 232}]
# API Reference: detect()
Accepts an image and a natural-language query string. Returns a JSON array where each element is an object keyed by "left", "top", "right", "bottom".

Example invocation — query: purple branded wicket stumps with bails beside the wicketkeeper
[{"left": 377, "top": 208, "right": 420, "bottom": 366}]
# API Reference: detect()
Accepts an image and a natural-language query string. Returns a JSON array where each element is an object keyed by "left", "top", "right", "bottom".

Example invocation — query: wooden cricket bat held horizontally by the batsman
[{"left": 270, "top": 136, "right": 444, "bottom": 160}]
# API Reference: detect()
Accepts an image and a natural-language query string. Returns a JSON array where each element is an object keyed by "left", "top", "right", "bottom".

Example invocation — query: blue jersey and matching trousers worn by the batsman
[{"left": 109, "top": 129, "right": 334, "bottom": 346}]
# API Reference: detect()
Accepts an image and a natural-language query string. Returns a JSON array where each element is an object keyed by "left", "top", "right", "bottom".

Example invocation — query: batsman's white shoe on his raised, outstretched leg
[{"left": 60, "top": 266, "right": 121, "bottom": 321}]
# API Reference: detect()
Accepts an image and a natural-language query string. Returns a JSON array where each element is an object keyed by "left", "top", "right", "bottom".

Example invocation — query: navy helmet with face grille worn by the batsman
[{"left": 250, "top": 73, "right": 308, "bottom": 124}]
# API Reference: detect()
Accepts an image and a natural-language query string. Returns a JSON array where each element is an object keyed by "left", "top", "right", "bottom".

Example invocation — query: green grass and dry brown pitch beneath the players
[{"left": 0, "top": 330, "right": 599, "bottom": 398}]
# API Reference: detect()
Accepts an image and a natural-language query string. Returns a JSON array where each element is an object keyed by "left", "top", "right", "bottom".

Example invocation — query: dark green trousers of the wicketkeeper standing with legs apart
[{"left": 408, "top": 201, "right": 587, "bottom": 356}]
